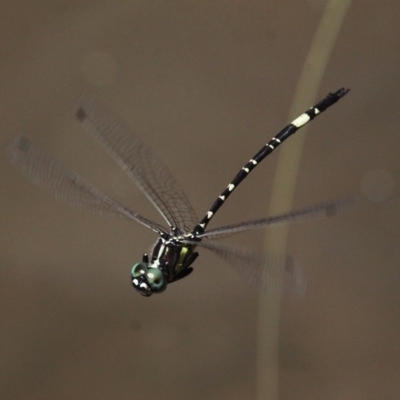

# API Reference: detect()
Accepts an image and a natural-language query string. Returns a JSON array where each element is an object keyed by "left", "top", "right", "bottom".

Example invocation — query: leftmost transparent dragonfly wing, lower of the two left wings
[{"left": 6, "top": 137, "right": 164, "bottom": 233}]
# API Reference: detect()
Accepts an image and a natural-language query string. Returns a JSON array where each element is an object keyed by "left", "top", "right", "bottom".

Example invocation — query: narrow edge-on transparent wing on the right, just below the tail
[{"left": 198, "top": 197, "right": 358, "bottom": 239}]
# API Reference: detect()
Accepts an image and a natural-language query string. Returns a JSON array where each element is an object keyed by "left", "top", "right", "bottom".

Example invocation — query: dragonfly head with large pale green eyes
[{"left": 131, "top": 262, "right": 167, "bottom": 297}]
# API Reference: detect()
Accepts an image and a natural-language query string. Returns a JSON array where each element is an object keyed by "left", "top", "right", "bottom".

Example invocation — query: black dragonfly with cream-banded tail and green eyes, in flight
[{"left": 6, "top": 88, "right": 349, "bottom": 297}]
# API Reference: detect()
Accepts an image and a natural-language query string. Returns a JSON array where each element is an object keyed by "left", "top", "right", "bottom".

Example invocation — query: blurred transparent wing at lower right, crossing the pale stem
[{"left": 188, "top": 241, "right": 307, "bottom": 295}]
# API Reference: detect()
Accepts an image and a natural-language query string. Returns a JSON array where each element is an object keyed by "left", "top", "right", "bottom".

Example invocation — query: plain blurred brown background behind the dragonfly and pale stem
[{"left": 0, "top": 0, "right": 400, "bottom": 400}]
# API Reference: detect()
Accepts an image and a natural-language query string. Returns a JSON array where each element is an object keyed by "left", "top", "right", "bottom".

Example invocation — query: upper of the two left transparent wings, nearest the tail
[{"left": 76, "top": 95, "right": 198, "bottom": 232}]
